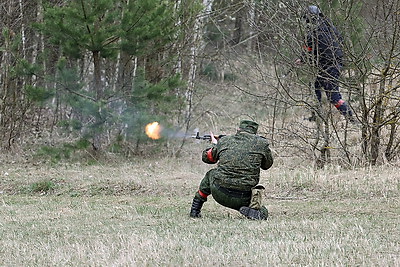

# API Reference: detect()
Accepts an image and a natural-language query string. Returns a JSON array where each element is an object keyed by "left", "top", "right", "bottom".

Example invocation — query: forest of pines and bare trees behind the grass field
[{"left": 0, "top": 0, "right": 400, "bottom": 167}]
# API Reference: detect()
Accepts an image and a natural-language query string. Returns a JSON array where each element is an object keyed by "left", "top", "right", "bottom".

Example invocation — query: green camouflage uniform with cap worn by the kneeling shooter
[{"left": 190, "top": 120, "right": 273, "bottom": 221}]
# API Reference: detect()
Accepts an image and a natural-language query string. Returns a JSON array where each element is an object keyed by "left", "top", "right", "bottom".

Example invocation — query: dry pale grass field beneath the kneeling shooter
[{"left": 0, "top": 150, "right": 400, "bottom": 266}]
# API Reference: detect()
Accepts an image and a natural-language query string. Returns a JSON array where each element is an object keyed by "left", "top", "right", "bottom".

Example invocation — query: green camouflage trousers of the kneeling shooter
[{"left": 195, "top": 169, "right": 262, "bottom": 213}]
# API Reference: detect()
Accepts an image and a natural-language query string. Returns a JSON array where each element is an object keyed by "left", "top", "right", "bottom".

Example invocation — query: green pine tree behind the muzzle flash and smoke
[{"left": 38, "top": 0, "right": 184, "bottom": 153}]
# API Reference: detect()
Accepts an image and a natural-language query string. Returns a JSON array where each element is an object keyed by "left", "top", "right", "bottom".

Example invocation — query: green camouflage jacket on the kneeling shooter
[{"left": 202, "top": 132, "right": 273, "bottom": 191}]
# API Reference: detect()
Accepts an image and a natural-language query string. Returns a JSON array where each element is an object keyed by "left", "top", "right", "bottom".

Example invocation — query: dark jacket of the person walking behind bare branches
[{"left": 306, "top": 18, "right": 343, "bottom": 69}]
